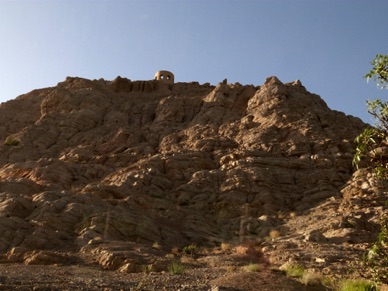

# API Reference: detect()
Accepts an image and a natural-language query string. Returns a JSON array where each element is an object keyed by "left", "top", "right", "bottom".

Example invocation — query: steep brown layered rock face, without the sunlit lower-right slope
[{"left": 0, "top": 77, "right": 365, "bottom": 262}]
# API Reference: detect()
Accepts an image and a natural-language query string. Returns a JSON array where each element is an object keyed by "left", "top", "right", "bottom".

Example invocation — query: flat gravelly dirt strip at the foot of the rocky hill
[{"left": 0, "top": 264, "right": 327, "bottom": 291}]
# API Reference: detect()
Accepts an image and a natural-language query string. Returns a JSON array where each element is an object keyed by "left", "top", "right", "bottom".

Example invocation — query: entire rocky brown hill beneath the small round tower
[{"left": 0, "top": 77, "right": 384, "bottom": 290}]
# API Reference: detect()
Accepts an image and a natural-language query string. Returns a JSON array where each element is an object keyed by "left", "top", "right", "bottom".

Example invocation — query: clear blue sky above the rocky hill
[{"left": 0, "top": 0, "right": 388, "bottom": 122}]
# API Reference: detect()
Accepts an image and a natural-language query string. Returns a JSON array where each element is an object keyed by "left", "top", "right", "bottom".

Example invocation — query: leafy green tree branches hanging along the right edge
[{"left": 353, "top": 54, "right": 388, "bottom": 284}]
